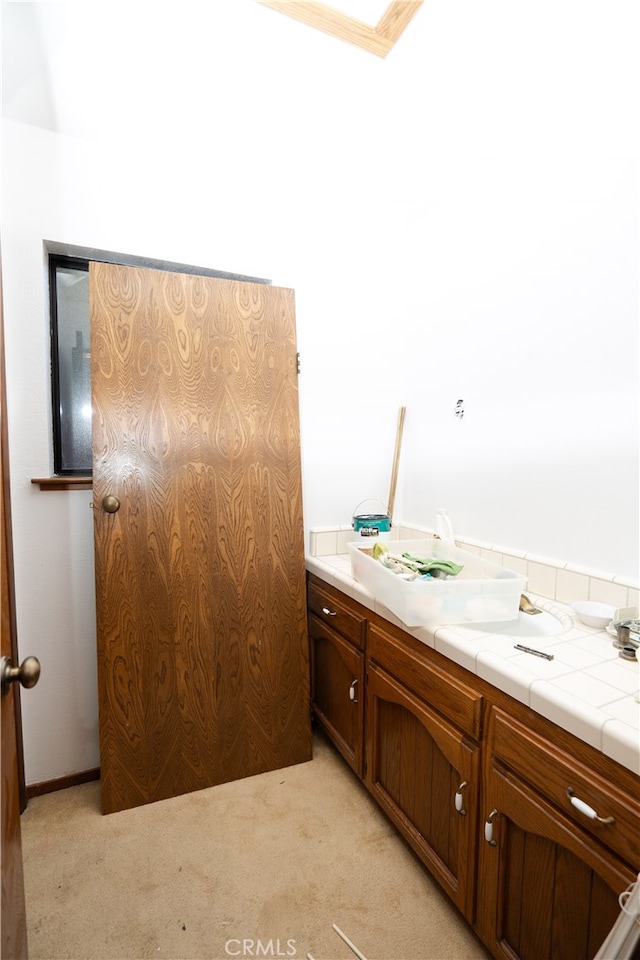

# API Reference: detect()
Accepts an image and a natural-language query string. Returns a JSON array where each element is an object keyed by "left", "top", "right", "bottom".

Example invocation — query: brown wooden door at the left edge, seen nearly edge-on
[{"left": 0, "top": 282, "right": 27, "bottom": 960}]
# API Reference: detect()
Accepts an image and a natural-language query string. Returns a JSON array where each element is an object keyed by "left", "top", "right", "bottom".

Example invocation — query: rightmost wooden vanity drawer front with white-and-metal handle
[{"left": 490, "top": 707, "right": 640, "bottom": 872}]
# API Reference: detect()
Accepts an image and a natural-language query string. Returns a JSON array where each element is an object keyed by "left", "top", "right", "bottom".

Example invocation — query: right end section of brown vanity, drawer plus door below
[{"left": 477, "top": 708, "right": 638, "bottom": 960}]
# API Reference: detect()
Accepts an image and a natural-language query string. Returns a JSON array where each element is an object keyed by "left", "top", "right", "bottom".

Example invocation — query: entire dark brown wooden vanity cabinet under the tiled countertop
[{"left": 309, "top": 577, "right": 640, "bottom": 960}]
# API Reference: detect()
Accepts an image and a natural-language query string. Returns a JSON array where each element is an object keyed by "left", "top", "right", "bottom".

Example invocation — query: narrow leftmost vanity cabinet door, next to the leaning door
[{"left": 309, "top": 613, "right": 364, "bottom": 777}]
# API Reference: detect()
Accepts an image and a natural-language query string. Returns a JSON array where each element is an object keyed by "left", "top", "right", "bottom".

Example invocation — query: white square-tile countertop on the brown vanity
[{"left": 306, "top": 553, "right": 640, "bottom": 774}]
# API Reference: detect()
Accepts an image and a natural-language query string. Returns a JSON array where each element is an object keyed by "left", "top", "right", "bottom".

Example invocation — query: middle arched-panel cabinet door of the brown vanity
[{"left": 365, "top": 663, "right": 479, "bottom": 920}]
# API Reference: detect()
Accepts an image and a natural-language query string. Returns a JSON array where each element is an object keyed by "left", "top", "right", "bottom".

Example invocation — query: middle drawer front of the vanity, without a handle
[{"left": 368, "top": 624, "right": 483, "bottom": 740}]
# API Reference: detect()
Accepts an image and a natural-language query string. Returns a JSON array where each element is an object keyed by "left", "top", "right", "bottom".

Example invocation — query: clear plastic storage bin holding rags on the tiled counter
[{"left": 347, "top": 537, "right": 526, "bottom": 627}]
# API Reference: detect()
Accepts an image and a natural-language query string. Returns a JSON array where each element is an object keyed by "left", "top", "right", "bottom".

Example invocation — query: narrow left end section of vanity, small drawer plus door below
[{"left": 307, "top": 577, "right": 367, "bottom": 778}]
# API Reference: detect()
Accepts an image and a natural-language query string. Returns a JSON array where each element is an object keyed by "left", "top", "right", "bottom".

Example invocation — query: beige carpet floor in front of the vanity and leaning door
[{"left": 22, "top": 735, "right": 488, "bottom": 960}]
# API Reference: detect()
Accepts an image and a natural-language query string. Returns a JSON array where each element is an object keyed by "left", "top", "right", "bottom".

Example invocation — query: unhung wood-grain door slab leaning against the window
[{"left": 90, "top": 263, "right": 311, "bottom": 813}]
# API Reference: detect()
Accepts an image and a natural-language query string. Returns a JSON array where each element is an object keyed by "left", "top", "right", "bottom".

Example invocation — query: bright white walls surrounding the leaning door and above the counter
[{"left": 1, "top": 0, "right": 639, "bottom": 783}]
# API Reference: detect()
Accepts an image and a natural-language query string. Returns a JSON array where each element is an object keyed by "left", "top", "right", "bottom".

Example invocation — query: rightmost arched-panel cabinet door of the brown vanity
[{"left": 478, "top": 765, "right": 635, "bottom": 960}]
